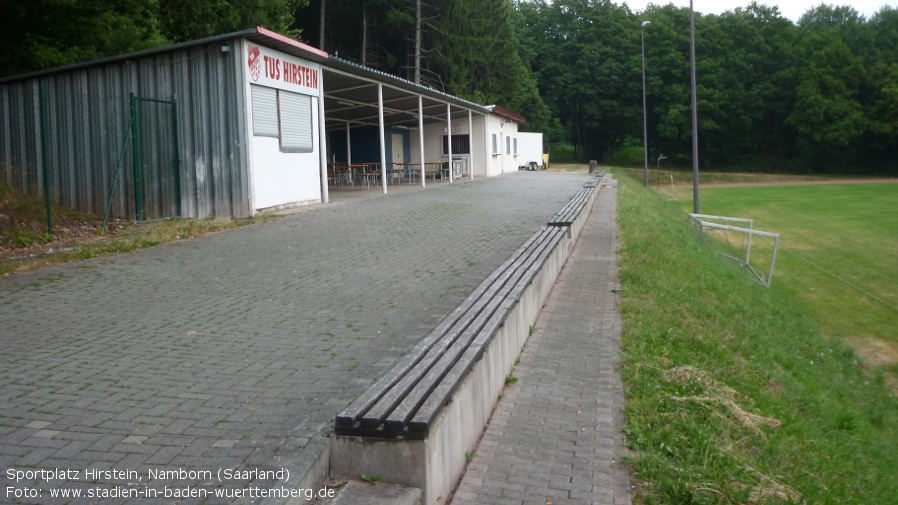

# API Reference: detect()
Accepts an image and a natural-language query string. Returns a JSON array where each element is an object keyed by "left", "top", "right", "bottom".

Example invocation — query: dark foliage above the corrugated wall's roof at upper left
[{"left": 0, "top": 0, "right": 308, "bottom": 77}]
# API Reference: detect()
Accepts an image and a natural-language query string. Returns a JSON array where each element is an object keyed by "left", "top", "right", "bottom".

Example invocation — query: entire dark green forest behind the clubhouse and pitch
[{"left": 0, "top": 0, "right": 898, "bottom": 175}]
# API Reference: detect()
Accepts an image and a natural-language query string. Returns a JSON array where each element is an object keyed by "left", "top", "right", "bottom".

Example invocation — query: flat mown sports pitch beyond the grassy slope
[{"left": 662, "top": 183, "right": 898, "bottom": 375}]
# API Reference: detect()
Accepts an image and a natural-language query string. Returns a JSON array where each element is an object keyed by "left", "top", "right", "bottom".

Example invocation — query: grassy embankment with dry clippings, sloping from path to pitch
[{"left": 619, "top": 169, "right": 898, "bottom": 504}]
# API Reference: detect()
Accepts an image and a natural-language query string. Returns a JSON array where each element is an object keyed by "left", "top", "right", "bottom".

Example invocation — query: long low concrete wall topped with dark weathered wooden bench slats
[{"left": 329, "top": 174, "right": 600, "bottom": 505}]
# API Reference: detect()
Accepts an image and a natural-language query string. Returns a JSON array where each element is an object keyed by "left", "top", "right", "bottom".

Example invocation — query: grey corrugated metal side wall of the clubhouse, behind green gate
[{"left": 0, "top": 41, "right": 252, "bottom": 218}]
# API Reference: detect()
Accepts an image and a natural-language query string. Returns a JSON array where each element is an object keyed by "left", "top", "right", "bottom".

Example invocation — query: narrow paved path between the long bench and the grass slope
[{"left": 452, "top": 177, "right": 630, "bottom": 505}]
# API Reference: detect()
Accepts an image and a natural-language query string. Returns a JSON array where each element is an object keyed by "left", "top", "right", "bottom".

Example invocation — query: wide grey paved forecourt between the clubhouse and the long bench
[{"left": 0, "top": 172, "right": 588, "bottom": 504}]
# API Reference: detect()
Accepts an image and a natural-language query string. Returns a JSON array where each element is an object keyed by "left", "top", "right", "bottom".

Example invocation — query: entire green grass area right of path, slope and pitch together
[{"left": 618, "top": 171, "right": 898, "bottom": 505}]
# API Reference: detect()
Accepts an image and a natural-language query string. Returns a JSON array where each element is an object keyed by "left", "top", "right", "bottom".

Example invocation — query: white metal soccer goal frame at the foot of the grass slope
[{"left": 689, "top": 213, "right": 780, "bottom": 288}]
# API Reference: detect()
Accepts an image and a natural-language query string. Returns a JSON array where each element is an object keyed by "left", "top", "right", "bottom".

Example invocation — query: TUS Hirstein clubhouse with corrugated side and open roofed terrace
[{"left": 0, "top": 27, "right": 524, "bottom": 220}]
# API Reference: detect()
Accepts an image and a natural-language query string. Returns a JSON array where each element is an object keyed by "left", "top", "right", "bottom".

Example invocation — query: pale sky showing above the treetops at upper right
[{"left": 613, "top": 0, "right": 898, "bottom": 21}]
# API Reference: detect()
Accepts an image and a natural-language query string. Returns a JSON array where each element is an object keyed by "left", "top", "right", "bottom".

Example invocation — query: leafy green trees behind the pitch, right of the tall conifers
[{"left": 517, "top": 0, "right": 898, "bottom": 174}]
